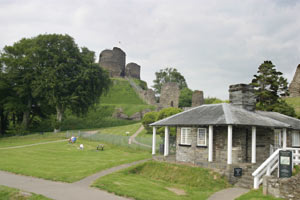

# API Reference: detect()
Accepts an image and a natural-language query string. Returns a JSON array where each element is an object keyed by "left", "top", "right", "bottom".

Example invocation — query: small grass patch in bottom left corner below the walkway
[{"left": 0, "top": 185, "right": 50, "bottom": 200}]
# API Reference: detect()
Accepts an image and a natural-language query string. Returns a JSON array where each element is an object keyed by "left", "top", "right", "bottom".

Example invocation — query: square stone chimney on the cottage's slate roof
[{"left": 229, "top": 83, "right": 256, "bottom": 111}]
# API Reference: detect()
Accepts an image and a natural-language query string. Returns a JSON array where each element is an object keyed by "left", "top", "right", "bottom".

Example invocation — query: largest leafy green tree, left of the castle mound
[{"left": 35, "top": 34, "right": 110, "bottom": 131}]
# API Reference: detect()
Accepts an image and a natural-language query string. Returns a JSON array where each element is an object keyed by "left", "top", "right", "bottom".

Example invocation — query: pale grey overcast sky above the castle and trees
[{"left": 0, "top": 0, "right": 300, "bottom": 99}]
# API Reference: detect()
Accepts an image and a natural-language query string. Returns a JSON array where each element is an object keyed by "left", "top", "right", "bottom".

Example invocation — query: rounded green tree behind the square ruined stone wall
[{"left": 152, "top": 68, "right": 187, "bottom": 94}]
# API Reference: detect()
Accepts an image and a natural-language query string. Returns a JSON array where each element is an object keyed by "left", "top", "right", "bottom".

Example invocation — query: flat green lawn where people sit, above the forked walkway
[{"left": 0, "top": 138, "right": 151, "bottom": 182}]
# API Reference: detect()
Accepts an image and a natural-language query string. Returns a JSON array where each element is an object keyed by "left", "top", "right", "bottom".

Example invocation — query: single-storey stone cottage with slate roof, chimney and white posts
[{"left": 151, "top": 84, "right": 300, "bottom": 187}]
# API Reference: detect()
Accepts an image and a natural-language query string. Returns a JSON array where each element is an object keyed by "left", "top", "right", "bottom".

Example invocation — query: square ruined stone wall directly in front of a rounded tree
[{"left": 159, "top": 82, "right": 180, "bottom": 108}]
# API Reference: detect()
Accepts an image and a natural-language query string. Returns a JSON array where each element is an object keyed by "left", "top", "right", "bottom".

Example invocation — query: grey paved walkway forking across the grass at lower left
[{"left": 0, "top": 159, "right": 150, "bottom": 200}]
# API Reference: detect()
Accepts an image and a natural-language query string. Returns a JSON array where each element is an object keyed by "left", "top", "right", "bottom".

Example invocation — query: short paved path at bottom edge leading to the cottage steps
[{"left": 207, "top": 187, "right": 249, "bottom": 200}]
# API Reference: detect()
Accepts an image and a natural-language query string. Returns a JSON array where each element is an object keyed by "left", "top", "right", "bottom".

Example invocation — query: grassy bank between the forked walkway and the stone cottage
[{"left": 93, "top": 161, "right": 229, "bottom": 200}]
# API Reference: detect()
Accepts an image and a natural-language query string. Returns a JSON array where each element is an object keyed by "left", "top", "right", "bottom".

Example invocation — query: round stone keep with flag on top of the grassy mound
[{"left": 99, "top": 47, "right": 141, "bottom": 79}]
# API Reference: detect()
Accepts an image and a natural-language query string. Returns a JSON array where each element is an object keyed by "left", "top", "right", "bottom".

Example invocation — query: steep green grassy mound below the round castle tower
[{"left": 31, "top": 78, "right": 155, "bottom": 132}]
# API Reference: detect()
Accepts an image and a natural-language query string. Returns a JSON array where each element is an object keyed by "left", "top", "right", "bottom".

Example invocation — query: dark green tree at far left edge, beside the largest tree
[{"left": 1, "top": 38, "right": 38, "bottom": 130}]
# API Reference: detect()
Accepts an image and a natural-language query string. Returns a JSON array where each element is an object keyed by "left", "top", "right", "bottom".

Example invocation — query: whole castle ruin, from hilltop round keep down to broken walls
[{"left": 99, "top": 47, "right": 204, "bottom": 109}]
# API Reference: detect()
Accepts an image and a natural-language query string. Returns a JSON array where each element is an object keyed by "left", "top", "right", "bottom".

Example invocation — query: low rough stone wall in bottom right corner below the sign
[{"left": 263, "top": 174, "right": 300, "bottom": 200}]
